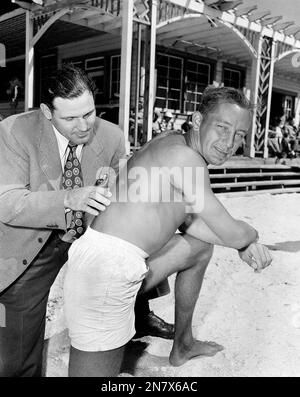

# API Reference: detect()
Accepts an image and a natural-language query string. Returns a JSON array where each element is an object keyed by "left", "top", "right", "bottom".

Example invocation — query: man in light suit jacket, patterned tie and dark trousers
[{"left": 0, "top": 66, "right": 173, "bottom": 376}]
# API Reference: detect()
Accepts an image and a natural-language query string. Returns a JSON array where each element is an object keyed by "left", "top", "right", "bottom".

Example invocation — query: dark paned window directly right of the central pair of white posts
[{"left": 155, "top": 53, "right": 183, "bottom": 111}]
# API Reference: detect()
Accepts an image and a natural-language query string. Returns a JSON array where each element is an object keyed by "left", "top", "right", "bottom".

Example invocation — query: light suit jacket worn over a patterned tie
[{"left": 0, "top": 110, "right": 125, "bottom": 291}]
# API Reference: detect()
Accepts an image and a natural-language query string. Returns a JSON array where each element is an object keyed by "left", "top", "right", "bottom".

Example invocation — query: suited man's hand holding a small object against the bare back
[{"left": 64, "top": 186, "right": 111, "bottom": 216}]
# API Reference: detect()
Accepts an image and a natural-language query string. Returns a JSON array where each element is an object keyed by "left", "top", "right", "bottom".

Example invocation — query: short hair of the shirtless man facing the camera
[{"left": 198, "top": 86, "right": 254, "bottom": 118}]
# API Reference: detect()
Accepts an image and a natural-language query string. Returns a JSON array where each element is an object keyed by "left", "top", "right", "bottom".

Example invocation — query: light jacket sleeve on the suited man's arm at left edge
[{"left": 0, "top": 121, "right": 66, "bottom": 229}]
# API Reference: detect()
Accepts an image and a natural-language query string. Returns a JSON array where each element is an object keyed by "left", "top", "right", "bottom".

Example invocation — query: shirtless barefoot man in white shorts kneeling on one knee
[{"left": 65, "top": 87, "right": 271, "bottom": 376}]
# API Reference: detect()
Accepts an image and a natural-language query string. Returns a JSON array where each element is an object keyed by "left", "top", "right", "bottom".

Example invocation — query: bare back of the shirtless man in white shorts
[{"left": 91, "top": 132, "right": 190, "bottom": 255}]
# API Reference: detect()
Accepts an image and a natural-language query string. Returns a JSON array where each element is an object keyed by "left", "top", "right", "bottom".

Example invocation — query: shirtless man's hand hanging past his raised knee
[{"left": 238, "top": 243, "right": 273, "bottom": 273}]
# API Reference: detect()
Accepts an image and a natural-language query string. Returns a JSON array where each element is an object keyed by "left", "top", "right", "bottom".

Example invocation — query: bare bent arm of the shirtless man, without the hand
[{"left": 169, "top": 147, "right": 258, "bottom": 249}]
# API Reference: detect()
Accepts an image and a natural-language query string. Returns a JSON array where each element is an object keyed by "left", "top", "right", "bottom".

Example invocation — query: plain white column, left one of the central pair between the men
[{"left": 119, "top": 0, "right": 133, "bottom": 154}]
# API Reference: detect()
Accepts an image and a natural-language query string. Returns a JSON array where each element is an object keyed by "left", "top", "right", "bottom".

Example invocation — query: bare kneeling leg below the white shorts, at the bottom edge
[{"left": 69, "top": 346, "right": 125, "bottom": 377}]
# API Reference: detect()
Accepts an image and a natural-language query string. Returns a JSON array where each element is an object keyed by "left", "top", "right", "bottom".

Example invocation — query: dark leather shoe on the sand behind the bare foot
[{"left": 134, "top": 312, "right": 175, "bottom": 339}]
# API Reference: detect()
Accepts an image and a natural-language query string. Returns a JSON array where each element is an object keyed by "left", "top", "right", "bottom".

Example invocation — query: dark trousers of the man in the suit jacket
[{"left": 0, "top": 232, "right": 70, "bottom": 377}]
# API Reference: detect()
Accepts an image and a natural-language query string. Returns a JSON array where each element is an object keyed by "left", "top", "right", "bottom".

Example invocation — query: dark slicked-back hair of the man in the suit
[{"left": 41, "top": 63, "right": 96, "bottom": 111}]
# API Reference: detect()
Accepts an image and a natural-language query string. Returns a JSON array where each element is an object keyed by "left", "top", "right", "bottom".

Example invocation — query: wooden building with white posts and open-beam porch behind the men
[{"left": 0, "top": 0, "right": 300, "bottom": 157}]
